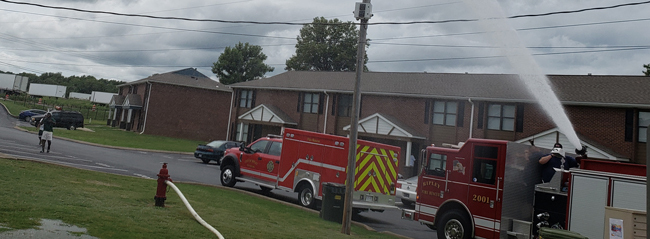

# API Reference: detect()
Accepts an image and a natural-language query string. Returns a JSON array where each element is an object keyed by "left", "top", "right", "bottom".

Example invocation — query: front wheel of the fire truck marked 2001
[{"left": 437, "top": 210, "right": 471, "bottom": 239}]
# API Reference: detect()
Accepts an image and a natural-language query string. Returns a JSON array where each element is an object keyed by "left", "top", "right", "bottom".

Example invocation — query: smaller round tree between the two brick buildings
[{"left": 212, "top": 42, "right": 275, "bottom": 85}]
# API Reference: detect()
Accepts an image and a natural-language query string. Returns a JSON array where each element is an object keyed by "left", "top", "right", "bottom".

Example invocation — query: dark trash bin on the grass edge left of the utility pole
[{"left": 319, "top": 183, "right": 345, "bottom": 223}]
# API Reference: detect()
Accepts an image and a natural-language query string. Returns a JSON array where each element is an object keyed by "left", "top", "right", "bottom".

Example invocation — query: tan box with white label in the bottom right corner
[{"left": 603, "top": 207, "right": 648, "bottom": 239}]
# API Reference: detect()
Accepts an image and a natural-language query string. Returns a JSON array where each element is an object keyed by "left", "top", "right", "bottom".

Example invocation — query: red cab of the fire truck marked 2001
[{"left": 403, "top": 139, "right": 524, "bottom": 238}]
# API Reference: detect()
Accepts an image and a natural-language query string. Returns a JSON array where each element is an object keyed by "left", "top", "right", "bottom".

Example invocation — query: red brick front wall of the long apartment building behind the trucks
[{"left": 231, "top": 87, "right": 643, "bottom": 161}]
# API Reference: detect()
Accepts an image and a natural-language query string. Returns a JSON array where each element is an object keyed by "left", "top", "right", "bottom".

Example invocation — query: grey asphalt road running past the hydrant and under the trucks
[{"left": 0, "top": 106, "right": 436, "bottom": 239}]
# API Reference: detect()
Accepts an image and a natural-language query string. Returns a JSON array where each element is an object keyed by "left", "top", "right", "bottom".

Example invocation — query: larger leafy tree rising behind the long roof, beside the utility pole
[{"left": 284, "top": 17, "right": 368, "bottom": 71}]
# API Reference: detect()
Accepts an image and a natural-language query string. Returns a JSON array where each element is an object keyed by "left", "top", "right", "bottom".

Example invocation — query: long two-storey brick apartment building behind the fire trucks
[{"left": 228, "top": 71, "right": 650, "bottom": 176}]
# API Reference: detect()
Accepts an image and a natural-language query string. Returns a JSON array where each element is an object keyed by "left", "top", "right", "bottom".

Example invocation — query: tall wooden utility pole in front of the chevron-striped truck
[{"left": 341, "top": 0, "right": 372, "bottom": 235}]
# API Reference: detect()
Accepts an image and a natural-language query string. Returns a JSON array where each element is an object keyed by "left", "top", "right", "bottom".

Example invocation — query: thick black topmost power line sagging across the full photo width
[{"left": 0, "top": 0, "right": 650, "bottom": 25}]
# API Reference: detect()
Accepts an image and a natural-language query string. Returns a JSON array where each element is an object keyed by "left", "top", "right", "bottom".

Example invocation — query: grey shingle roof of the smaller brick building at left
[{"left": 118, "top": 68, "right": 232, "bottom": 92}]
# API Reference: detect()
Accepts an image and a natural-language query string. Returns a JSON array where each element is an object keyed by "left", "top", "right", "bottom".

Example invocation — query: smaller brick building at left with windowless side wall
[{"left": 107, "top": 68, "right": 232, "bottom": 141}]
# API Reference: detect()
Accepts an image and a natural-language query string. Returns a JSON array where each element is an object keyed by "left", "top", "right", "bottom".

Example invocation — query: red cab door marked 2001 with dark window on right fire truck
[{"left": 467, "top": 144, "right": 505, "bottom": 238}]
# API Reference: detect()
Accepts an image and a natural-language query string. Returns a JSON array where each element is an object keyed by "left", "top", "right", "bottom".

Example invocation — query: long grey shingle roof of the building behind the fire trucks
[{"left": 230, "top": 71, "right": 650, "bottom": 108}]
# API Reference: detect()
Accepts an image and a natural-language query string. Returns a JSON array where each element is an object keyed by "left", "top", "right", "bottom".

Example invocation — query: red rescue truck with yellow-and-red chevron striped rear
[{"left": 221, "top": 129, "right": 400, "bottom": 211}]
